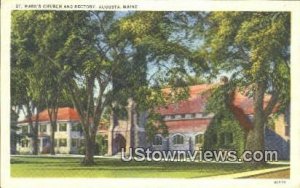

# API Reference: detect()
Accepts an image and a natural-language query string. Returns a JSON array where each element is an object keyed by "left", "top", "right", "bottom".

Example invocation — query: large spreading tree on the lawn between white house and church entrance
[{"left": 59, "top": 12, "right": 191, "bottom": 164}]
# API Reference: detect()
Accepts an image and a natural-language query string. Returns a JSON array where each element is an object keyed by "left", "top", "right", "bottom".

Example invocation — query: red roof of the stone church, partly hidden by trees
[{"left": 157, "top": 84, "right": 276, "bottom": 132}]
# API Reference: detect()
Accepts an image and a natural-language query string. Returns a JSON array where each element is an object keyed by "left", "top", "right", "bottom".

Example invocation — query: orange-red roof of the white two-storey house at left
[{"left": 19, "top": 107, "right": 80, "bottom": 123}]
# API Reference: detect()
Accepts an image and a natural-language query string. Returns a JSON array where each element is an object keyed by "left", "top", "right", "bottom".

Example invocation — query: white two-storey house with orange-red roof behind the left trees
[{"left": 17, "top": 107, "right": 84, "bottom": 154}]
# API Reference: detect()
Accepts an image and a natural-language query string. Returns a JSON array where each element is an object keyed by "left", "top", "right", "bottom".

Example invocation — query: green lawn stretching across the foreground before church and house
[{"left": 11, "top": 157, "right": 288, "bottom": 178}]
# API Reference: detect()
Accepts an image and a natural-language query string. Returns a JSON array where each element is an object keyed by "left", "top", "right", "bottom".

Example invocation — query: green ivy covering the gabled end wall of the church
[{"left": 204, "top": 83, "right": 246, "bottom": 155}]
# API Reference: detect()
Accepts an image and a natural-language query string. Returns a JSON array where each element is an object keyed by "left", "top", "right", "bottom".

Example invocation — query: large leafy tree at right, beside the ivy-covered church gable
[{"left": 190, "top": 12, "right": 290, "bottom": 162}]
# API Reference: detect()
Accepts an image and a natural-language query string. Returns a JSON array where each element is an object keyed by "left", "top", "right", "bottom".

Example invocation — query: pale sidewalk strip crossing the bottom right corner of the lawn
[{"left": 203, "top": 166, "right": 290, "bottom": 179}]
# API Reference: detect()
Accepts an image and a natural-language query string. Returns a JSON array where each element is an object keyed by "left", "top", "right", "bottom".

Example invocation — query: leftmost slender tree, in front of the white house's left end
[{"left": 11, "top": 12, "right": 45, "bottom": 155}]
